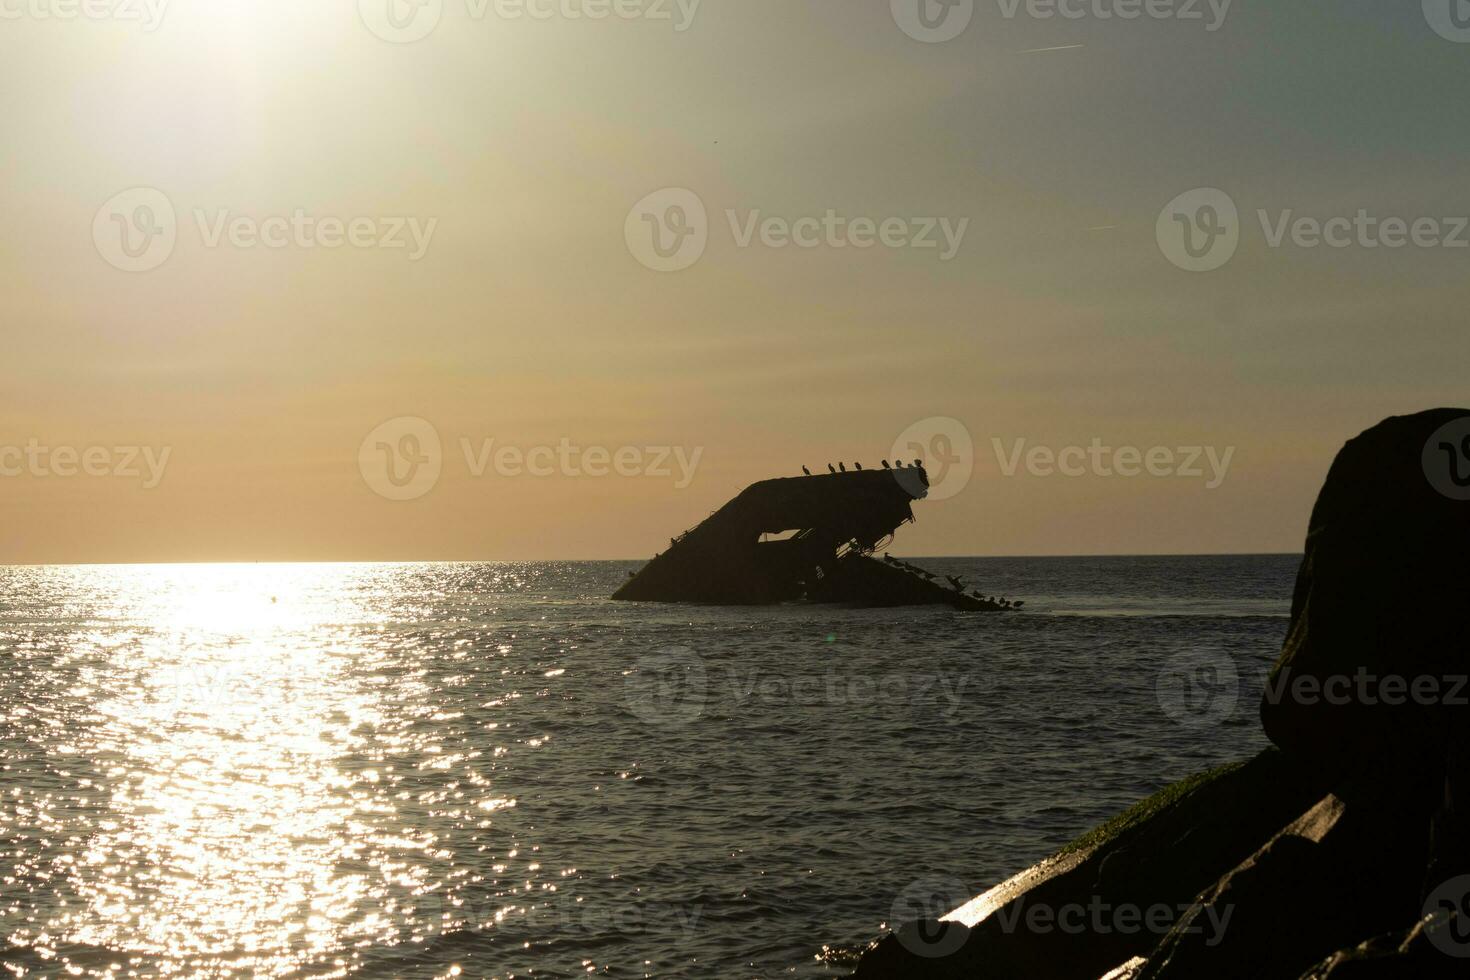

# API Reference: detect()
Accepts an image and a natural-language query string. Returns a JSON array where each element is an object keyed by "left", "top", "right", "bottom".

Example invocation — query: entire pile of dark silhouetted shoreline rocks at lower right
[{"left": 856, "top": 408, "right": 1470, "bottom": 980}]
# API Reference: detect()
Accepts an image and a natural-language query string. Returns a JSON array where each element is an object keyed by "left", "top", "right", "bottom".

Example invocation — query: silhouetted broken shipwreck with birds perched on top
[{"left": 613, "top": 463, "right": 1023, "bottom": 613}]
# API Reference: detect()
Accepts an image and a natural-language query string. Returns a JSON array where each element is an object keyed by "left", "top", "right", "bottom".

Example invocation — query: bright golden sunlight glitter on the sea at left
[{"left": 6, "top": 566, "right": 529, "bottom": 976}]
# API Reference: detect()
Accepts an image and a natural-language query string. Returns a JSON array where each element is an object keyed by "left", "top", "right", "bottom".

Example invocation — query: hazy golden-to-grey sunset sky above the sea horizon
[{"left": 0, "top": 0, "right": 1470, "bottom": 563}]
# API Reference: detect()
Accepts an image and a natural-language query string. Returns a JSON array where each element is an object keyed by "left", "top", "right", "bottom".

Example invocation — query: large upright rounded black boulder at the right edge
[{"left": 1261, "top": 408, "right": 1470, "bottom": 776}]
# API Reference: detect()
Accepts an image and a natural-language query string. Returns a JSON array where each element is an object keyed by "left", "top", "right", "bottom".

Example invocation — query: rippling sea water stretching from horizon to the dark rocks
[{"left": 0, "top": 557, "right": 1298, "bottom": 977}]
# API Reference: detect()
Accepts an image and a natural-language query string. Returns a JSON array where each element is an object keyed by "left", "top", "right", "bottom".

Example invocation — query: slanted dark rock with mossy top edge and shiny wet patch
[{"left": 854, "top": 751, "right": 1326, "bottom": 980}]
